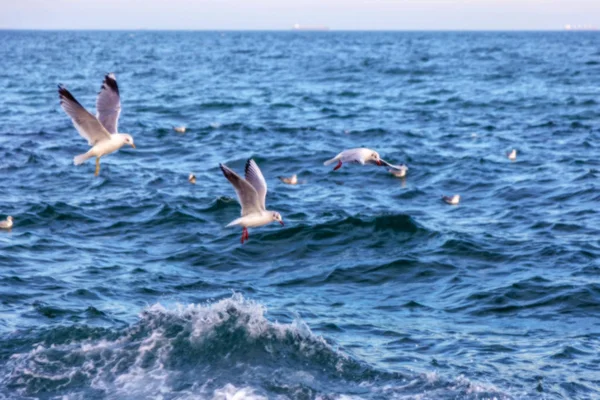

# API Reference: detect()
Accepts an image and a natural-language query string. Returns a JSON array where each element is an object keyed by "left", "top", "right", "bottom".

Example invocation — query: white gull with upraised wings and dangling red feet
[{"left": 219, "top": 159, "right": 283, "bottom": 244}]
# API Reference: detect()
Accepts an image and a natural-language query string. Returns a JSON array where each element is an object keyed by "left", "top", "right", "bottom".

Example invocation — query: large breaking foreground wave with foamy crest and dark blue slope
[{"left": 0, "top": 294, "right": 510, "bottom": 399}]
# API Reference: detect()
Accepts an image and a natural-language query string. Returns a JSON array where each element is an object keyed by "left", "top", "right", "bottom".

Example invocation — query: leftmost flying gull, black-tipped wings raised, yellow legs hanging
[{"left": 58, "top": 73, "right": 135, "bottom": 176}]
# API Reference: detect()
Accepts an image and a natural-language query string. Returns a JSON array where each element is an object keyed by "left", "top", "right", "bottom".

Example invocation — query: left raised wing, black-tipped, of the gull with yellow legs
[{"left": 58, "top": 85, "right": 110, "bottom": 146}]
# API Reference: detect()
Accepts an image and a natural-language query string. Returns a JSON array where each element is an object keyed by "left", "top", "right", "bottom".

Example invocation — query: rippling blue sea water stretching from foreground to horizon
[{"left": 0, "top": 31, "right": 600, "bottom": 399}]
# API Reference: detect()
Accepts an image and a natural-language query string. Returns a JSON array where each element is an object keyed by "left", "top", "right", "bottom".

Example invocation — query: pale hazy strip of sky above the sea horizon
[{"left": 0, "top": 0, "right": 600, "bottom": 30}]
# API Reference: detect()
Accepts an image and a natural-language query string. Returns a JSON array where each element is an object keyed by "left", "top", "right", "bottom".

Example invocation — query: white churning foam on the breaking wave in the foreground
[{"left": 0, "top": 294, "right": 333, "bottom": 399}]
